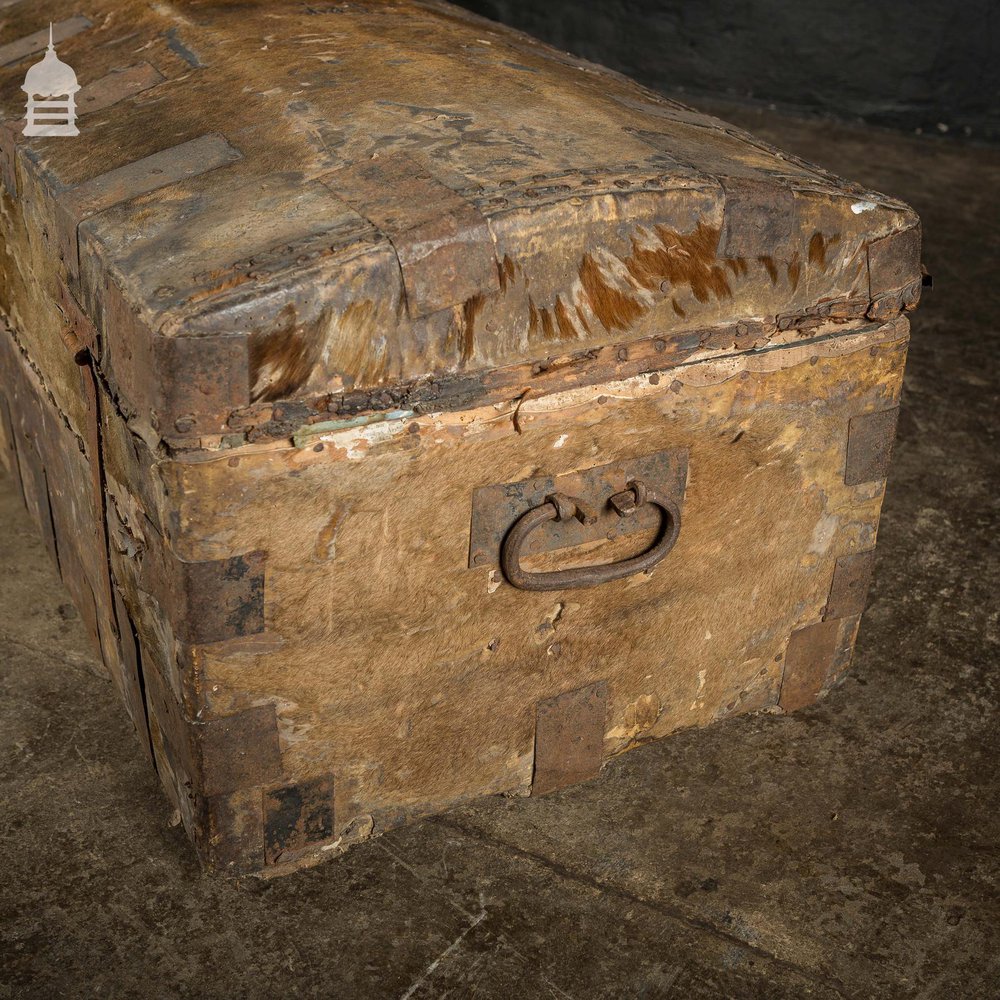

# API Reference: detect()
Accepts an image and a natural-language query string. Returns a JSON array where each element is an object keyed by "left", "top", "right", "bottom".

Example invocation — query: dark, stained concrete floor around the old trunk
[{"left": 0, "top": 102, "right": 1000, "bottom": 1000}]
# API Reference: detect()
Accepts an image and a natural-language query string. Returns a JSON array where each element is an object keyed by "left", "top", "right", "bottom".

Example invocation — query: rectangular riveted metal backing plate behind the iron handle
[{"left": 469, "top": 448, "right": 688, "bottom": 568}]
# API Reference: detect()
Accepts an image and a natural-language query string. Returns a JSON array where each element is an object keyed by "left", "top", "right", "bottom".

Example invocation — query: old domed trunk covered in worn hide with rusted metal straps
[{"left": 0, "top": 0, "right": 921, "bottom": 872}]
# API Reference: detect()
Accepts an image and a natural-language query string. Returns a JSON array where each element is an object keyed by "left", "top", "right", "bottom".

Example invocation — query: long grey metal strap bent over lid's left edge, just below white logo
[{"left": 56, "top": 133, "right": 242, "bottom": 278}]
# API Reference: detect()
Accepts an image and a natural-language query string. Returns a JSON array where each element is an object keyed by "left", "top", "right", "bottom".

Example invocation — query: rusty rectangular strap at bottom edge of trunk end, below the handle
[{"left": 531, "top": 681, "right": 608, "bottom": 795}]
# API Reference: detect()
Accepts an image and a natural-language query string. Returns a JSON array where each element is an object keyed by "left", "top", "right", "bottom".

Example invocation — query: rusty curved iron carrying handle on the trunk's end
[{"left": 500, "top": 479, "right": 681, "bottom": 590}]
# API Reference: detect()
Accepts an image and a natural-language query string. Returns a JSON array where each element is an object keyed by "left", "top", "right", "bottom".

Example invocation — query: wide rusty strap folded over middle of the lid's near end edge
[{"left": 322, "top": 153, "right": 500, "bottom": 318}]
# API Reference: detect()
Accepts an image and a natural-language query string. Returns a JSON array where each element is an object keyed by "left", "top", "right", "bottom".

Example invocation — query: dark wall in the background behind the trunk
[{"left": 459, "top": 0, "right": 1000, "bottom": 141}]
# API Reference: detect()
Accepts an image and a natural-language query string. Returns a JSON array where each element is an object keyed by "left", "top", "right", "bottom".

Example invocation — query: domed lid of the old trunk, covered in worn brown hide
[{"left": 0, "top": 0, "right": 919, "bottom": 435}]
